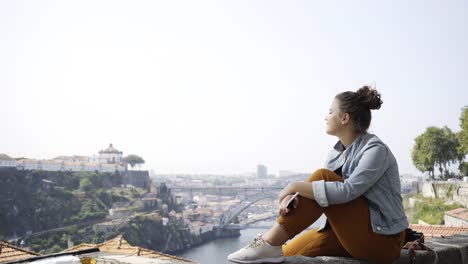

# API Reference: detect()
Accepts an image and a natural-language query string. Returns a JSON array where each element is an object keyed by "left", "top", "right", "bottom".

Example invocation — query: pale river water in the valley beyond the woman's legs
[{"left": 178, "top": 218, "right": 324, "bottom": 264}]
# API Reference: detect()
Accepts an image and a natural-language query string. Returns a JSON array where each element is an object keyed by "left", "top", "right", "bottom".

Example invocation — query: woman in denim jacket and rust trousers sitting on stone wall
[{"left": 228, "top": 86, "right": 408, "bottom": 263}]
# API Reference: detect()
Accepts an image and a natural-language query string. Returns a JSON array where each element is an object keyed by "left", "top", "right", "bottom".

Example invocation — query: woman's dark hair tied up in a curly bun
[{"left": 335, "top": 85, "right": 383, "bottom": 133}]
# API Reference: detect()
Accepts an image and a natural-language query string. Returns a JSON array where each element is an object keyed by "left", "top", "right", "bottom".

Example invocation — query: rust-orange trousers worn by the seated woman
[{"left": 277, "top": 169, "right": 405, "bottom": 263}]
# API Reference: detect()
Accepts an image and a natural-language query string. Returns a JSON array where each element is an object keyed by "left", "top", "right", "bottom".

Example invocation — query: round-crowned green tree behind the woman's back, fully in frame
[{"left": 411, "top": 127, "right": 460, "bottom": 179}]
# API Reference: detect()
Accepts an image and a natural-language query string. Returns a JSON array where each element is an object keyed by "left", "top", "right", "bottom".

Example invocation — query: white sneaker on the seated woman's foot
[{"left": 228, "top": 234, "right": 284, "bottom": 263}]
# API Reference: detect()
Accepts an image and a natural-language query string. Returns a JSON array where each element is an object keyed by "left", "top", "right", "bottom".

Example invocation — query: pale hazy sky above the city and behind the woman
[{"left": 0, "top": 0, "right": 468, "bottom": 174}]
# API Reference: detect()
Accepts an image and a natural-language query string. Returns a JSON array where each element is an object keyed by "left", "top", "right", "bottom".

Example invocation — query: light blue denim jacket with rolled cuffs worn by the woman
[{"left": 312, "top": 133, "right": 408, "bottom": 235}]
